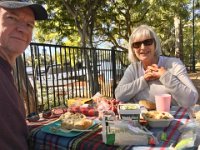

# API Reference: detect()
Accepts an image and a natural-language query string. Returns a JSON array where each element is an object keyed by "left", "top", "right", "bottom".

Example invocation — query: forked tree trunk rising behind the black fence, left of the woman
[{"left": 63, "top": 0, "right": 107, "bottom": 94}]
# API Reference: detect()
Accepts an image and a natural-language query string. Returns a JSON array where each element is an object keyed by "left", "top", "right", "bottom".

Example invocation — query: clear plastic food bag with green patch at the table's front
[{"left": 102, "top": 116, "right": 158, "bottom": 145}]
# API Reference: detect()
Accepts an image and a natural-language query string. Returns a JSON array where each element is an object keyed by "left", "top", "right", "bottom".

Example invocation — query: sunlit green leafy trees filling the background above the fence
[{"left": 35, "top": 0, "right": 200, "bottom": 65}]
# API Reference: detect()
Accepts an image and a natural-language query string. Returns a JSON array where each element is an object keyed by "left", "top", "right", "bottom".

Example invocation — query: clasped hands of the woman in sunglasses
[{"left": 144, "top": 64, "right": 166, "bottom": 81}]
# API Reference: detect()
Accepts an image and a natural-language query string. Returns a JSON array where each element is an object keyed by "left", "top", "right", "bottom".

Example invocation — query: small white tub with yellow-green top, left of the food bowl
[{"left": 118, "top": 103, "right": 141, "bottom": 121}]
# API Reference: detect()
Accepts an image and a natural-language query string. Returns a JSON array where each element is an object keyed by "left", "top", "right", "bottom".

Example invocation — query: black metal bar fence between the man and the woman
[{"left": 16, "top": 43, "right": 128, "bottom": 112}]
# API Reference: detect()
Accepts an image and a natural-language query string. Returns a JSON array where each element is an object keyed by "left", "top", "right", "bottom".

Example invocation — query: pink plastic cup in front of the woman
[{"left": 155, "top": 94, "right": 171, "bottom": 112}]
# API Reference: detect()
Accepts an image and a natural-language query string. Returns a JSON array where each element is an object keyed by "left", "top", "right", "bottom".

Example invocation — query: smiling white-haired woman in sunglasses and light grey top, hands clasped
[{"left": 115, "top": 25, "right": 198, "bottom": 108}]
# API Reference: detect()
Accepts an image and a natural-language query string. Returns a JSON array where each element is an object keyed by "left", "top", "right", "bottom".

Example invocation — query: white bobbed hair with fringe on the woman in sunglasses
[{"left": 128, "top": 25, "right": 162, "bottom": 62}]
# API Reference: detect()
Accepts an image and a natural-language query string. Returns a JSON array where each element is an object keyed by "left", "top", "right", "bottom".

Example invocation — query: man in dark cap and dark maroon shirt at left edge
[{"left": 0, "top": 0, "right": 47, "bottom": 150}]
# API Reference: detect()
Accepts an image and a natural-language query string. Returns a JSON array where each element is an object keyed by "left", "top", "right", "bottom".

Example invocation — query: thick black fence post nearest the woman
[{"left": 111, "top": 47, "right": 117, "bottom": 98}]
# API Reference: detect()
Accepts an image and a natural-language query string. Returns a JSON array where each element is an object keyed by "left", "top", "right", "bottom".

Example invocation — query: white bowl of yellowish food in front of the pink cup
[{"left": 142, "top": 111, "right": 174, "bottom": 128}]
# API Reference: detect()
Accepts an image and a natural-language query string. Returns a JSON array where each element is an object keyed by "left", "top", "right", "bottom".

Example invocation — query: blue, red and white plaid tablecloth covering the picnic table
[{"left": 29, "top": 107, "right": 189, "bottom": 150}]
